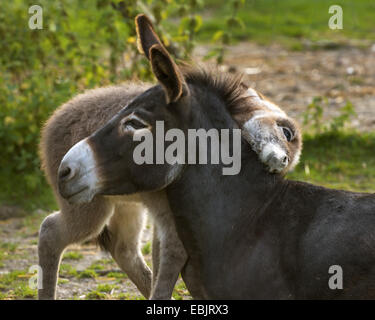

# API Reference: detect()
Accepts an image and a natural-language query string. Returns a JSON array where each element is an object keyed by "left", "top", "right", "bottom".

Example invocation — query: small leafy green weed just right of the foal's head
[{"left": 303, "top": 97, "right": 356, "bottom": 134}]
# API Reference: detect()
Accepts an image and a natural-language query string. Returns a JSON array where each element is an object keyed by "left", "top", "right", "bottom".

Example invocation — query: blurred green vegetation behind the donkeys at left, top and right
[{"left": 0, "top": 0, "right": 375, "bottom": 210}]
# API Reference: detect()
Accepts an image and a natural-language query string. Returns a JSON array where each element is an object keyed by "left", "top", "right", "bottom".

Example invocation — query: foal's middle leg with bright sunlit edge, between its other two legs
[{"left": 106, "top": 202, "right": 152, "bottom": 298}]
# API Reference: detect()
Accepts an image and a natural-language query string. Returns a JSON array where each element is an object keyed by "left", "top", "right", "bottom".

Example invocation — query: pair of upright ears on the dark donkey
[{"left": 135, "top": 14, "right": 188, "bottom": 103}]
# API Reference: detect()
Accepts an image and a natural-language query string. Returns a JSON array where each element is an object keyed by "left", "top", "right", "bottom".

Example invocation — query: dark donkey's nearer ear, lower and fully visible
[{"left": 150, "top": 44, "right": 187, "bottom": 103}]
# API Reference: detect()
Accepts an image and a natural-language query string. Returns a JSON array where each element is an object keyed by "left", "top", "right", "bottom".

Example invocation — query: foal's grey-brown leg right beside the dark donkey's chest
[{"left": 151, "top": 212, "right": 187, "bottom": 300}]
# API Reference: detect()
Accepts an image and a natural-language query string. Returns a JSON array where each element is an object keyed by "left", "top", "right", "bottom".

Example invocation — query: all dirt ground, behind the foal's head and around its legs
[{"left": 0, "top": 43, "right": 375, "bottom": 299}]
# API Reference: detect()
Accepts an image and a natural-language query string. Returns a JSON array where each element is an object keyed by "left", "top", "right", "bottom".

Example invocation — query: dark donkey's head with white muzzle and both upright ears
[{"left": 58, "top": 15, "right": 194, "bottom": 203}]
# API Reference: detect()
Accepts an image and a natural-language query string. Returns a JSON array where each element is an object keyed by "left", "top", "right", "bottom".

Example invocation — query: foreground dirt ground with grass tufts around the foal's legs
[{"left": 0, "top": 210, "right": 190, "bottom": 300}]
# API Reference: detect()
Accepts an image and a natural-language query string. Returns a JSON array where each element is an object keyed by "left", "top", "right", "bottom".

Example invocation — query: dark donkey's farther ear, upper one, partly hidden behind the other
[{"left": 135, "top": 14, "right": 163, "bottom": 60}]
